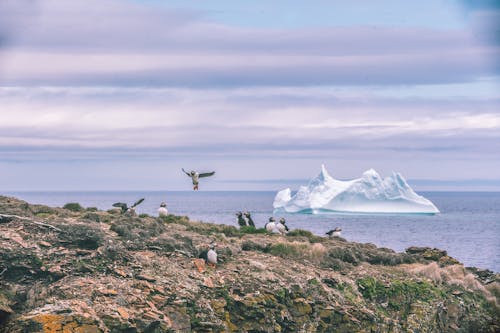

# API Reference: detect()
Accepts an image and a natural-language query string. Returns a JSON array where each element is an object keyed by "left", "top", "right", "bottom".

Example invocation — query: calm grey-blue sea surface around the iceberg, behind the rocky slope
[{"left": 2, "top": 191, "right": 500, "bottom": 272}]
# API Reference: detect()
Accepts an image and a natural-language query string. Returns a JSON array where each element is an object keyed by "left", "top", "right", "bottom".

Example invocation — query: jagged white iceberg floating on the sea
[{"left": 273, "top": 165, "right": 439, "bottom": 215}]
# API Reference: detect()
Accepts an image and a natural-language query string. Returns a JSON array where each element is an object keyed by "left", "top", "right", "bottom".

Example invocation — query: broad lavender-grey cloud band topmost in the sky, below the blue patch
[{"left": 0, "top": 0, "right": 500, "bottom": 87}]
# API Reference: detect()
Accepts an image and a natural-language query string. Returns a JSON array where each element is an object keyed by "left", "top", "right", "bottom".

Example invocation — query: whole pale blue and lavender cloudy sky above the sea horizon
[{"left": 0, "top": 0, "right": 500, "bottom": 191}]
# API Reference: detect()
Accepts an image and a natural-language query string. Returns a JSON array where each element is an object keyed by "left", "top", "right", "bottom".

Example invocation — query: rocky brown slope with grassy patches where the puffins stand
[{"left": 0, "top": 196, "right": 500, "bottom": 333}]
